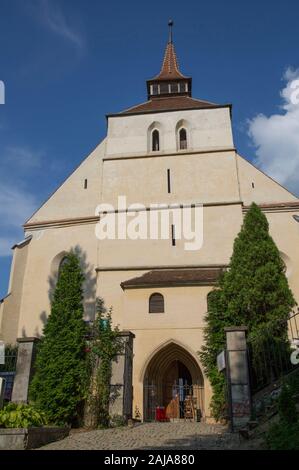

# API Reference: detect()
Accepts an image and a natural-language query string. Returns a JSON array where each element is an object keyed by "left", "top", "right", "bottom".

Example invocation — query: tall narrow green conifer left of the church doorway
[{"left": 30, "top": 251, "right": 87, "bottom": 424}]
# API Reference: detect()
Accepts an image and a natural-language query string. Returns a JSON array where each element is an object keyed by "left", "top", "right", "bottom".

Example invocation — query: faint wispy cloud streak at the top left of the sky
[{"left": 40, "top": 0, "right": 84, "bottom": 50}]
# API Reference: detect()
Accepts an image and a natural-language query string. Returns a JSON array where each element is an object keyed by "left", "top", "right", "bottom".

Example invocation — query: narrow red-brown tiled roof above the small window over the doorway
[{"left": 121, "top": 268, "right": 222, "bottom": 289}]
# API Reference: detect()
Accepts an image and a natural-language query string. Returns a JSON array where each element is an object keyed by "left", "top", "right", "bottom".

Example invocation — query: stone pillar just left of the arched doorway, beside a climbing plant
[{"left": 109, "top": 331, "right": 135, "bottom": 420}]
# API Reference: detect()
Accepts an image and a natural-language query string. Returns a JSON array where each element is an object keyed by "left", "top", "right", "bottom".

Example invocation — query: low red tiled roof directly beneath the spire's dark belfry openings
[{"left": 120, "top": 96, "right": 219, "bottom": 114}]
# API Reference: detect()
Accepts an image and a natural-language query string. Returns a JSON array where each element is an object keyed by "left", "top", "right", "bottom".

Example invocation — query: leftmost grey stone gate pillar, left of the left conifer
[{"left": 11, "top": 338, "right": 39, "bottom": 403}]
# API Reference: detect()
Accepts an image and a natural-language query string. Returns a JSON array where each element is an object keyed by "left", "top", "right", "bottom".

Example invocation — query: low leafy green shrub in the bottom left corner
[{"left": 0, "top": 403, "right": 47, "bottom": 428}]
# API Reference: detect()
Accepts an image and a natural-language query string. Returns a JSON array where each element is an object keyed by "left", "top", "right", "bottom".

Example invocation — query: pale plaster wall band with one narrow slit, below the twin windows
[{"left": 102, "top": 151, "right": 240, "bottom": 207}]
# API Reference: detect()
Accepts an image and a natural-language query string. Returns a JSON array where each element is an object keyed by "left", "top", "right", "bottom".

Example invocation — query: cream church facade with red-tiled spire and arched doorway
[{"left": 0, "top": 27, "right": 299, "bottom": 420}]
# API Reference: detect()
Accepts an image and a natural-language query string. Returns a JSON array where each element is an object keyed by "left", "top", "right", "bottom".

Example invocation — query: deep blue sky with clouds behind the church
[{"left": 0, "top": 0, "right": 299, "bottom": 297}]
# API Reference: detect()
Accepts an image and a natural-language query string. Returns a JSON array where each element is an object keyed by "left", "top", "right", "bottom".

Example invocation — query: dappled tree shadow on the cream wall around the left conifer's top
[{"left": 22, "top": 245, "right": 96, "bottom": 338}]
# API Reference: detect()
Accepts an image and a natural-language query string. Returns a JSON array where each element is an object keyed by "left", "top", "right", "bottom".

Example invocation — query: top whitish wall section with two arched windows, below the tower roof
[{"left": 106, "top": 107, "right": 234, "bottom": 156}]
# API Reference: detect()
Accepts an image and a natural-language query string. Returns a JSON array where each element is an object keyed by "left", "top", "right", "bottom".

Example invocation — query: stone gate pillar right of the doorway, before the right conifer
[{"left": 225, "top": 326, "right": 251, "bottom": 431}]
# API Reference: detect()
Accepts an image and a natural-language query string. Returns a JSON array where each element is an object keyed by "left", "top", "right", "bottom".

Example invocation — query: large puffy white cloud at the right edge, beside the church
[{"left": 248, "top": 68, "right": 299, "bottom": 194}]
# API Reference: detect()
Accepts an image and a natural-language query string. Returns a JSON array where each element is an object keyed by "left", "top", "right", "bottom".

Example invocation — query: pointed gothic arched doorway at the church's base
[{"left": 143, "top": 343, "right": 204, "bottom": 420}]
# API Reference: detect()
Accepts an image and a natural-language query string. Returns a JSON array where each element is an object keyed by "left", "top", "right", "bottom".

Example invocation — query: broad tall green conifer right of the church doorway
[{"left": 200, "top": 203, "right": 295, "bottom": 419}]
